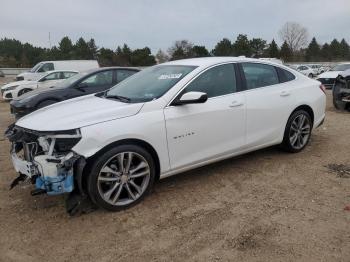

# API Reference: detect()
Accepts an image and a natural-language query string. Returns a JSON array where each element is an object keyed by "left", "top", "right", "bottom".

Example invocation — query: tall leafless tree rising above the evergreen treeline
[{"left": 278, "top": 22, "right": 309, "bottom": 53}]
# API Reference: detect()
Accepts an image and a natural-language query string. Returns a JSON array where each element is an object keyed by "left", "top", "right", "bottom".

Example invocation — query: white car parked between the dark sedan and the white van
[{"left": 1, "top": 70, "right": 78, "bottom": 100}]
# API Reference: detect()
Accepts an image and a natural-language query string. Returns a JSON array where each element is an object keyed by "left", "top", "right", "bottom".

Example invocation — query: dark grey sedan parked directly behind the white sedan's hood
[{"left": 10, "top": 67, "right": 140, "bottom": 119}]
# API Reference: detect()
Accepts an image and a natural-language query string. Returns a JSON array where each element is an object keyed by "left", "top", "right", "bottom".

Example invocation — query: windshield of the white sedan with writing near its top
[{"left": 106, "top": 65, "right": 196, "bottom": 102}]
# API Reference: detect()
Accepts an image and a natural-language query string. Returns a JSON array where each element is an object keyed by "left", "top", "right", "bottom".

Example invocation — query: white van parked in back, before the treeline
[{"left": 16, "top": 60, "right": 99, "bottom": 81}]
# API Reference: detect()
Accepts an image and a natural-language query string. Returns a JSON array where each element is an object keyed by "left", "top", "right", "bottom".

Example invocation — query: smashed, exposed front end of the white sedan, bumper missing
[{"left": 5, "top": 125, "right": 85, "bottom": 195}]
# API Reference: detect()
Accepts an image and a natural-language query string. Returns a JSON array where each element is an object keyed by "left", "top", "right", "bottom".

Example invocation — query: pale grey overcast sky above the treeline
[{"left": 0, "top": 0, "right": 350, "bottom": 52}]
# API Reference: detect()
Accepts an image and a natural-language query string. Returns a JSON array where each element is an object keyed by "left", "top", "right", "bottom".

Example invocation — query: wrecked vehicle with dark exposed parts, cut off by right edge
[{"left": 333, "top": 69, "right": 350, "bottom": 110}]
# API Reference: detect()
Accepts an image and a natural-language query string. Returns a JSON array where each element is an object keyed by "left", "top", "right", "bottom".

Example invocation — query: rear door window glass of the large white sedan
[{"left": 242, "top": 63, "right": 279, "bottom": 89}]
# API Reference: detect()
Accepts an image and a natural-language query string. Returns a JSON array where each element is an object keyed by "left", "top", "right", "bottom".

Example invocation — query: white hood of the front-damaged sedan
[{"left": 16, "top": 95, "right": 144, "bottom": 131}]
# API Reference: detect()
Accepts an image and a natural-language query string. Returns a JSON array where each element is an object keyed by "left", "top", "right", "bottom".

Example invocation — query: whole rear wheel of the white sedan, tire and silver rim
[{"left": 282, "top": 110, "right": 312, "bottom": 153}]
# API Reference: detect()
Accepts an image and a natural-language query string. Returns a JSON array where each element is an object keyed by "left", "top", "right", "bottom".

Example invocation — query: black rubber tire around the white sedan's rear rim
[{"left": 281, "top": 110, "right": 312, "bottom": 153}]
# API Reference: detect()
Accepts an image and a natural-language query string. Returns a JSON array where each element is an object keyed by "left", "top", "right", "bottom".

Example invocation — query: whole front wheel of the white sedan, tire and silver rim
[{"left": 87, "top": 145, "right": 155, "bottom": 211}]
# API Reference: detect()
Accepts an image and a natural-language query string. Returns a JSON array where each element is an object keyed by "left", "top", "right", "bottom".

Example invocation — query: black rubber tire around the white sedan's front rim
[{"left": 86, "top": 145, "right": 156, "bottom": 211}]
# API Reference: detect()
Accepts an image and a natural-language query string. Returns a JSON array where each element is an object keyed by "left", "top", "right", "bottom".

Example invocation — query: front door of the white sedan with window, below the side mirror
[{"left": 164, "top": 64, "right": 245, "bottom": 169}]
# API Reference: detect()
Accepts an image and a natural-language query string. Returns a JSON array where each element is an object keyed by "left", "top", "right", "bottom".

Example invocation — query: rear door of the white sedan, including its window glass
[{"left": 241, "top": 63, "right": 294, "bottom": 148}]
